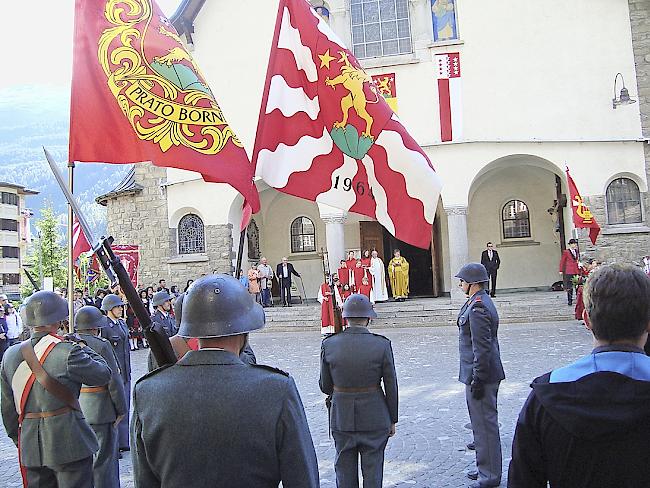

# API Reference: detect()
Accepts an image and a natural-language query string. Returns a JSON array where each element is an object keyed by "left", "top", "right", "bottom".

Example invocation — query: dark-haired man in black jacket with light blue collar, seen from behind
[{"left": 508, "top": 266, "right": 650, "bottom": 488}]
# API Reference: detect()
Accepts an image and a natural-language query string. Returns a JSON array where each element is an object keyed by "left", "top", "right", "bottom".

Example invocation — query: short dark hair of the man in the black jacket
[{"left": 584, "top": 265, "right": 650, "bottom": 342}]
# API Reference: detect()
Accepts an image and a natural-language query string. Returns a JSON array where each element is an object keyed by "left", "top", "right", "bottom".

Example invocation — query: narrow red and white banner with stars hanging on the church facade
[{"left": 436, "top": 53, "right": 463, "bottom": 142}]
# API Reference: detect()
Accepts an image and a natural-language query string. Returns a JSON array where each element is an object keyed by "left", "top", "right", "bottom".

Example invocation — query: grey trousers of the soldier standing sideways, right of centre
[{"left": 465, "top": 383, "right": 501, "bottom": 487}]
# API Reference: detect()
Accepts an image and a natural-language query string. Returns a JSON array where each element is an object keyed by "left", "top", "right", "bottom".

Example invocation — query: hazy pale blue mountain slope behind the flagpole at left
[{"left": 0, "top": 85, "right": 130, "bottom": 235}]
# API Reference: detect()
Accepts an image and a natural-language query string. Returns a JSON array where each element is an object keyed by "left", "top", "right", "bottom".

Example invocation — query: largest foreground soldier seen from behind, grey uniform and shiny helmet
[{"left": 131, "top": 275, "right": 318, "bottom": 488}]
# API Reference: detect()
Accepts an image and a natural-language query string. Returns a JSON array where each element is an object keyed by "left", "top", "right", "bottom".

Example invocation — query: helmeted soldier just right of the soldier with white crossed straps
[{"left": 75, "top": 305, "right": 126, "bottom": 488}]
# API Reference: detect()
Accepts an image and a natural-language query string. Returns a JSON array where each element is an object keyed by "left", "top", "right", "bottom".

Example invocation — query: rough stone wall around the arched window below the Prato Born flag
[{"left": 106, "top": 163, "right": 233, "bottom": 291}]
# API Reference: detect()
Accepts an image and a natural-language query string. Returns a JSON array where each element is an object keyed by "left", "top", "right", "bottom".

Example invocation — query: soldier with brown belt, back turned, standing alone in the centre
[{"left": 319, "top": 293, "right": 398, "bottom": 488}]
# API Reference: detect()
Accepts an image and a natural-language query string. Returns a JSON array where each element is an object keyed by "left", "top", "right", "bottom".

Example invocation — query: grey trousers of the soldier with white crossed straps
[{"left": 25, "top": 457, "right": 93, "bottom": 488}]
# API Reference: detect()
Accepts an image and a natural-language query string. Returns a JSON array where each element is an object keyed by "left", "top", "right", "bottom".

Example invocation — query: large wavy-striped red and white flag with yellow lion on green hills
[{"left": 253, "top": 0, "right": 441, "bottom": 248}]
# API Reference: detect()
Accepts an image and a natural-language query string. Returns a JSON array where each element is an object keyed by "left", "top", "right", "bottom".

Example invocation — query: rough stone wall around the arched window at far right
[{"left": 567, "top": 193, "right": 650, "bottom": 264}]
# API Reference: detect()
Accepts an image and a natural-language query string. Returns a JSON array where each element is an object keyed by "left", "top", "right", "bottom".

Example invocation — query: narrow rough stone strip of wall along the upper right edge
[{"left": 628, "top": 0, "right": 650, "bottom": 225}]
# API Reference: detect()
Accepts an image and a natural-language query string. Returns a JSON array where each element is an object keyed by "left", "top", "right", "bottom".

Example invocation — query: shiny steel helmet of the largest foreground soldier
[{"left": 178, "top": 274, "right": 266, "bottom": 339}]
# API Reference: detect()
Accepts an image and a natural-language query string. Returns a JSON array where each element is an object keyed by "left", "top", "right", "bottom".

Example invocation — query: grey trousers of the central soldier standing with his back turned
[{"left": 332, "top": 430, "right": 388, "bottom": 488}]
